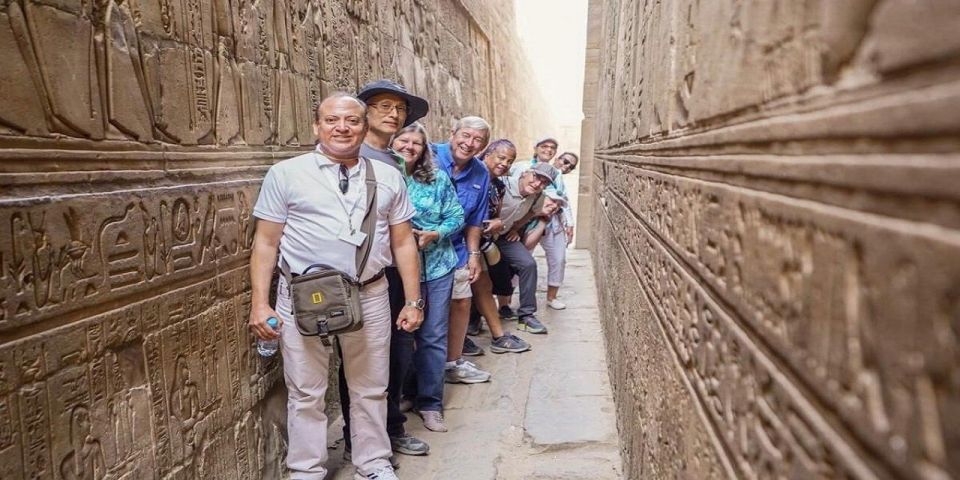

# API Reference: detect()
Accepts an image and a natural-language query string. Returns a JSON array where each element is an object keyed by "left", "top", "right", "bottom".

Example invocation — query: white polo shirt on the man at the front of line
[{"left": 253, "top": 151, "right": 416, "bottom": 288}]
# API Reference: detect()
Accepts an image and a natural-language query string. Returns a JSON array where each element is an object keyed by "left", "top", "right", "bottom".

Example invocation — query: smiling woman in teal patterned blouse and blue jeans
[{"left": 391, "top": 122, "right": 463, "bottom": 431}]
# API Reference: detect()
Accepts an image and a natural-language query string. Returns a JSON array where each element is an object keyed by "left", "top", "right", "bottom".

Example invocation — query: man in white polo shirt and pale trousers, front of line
[{"left": 250, "top": 94, "right": 422, "bottom": 480}]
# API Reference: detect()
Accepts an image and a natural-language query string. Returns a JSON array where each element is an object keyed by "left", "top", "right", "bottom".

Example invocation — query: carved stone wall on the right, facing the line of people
[{"left": 580, "top": 0, "right": 960, "bottom": 480}]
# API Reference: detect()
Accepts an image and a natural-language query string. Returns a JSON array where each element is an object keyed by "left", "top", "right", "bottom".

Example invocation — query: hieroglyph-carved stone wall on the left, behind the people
[{"left": 0, "top": 0, "right": 543, "bottom": 479}]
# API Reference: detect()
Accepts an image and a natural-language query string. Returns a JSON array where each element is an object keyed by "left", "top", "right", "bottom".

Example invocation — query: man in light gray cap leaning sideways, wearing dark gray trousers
[{"left": 490, "top": 163, "right": 559, "bottom": 333}]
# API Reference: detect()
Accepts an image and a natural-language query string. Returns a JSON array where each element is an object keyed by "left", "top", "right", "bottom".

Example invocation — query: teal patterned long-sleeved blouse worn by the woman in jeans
[{"left": 407, "top": 169, "right": 463, "bottom": 281}]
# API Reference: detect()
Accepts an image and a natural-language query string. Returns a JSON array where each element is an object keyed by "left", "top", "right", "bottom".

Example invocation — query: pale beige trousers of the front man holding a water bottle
[{"left": 276, "top": 277, "right": 391, "bottom": 480}]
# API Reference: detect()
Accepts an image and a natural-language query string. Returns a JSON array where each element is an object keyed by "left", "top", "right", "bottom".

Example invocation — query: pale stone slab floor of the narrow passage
[{"left": 328, "top": 249, "right": 621, "bottom": 480}]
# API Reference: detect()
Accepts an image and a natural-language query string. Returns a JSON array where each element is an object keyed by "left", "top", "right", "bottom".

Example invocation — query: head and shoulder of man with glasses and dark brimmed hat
[{"left": 357, "top": 80, "right": 430, "bottom": 169}]
